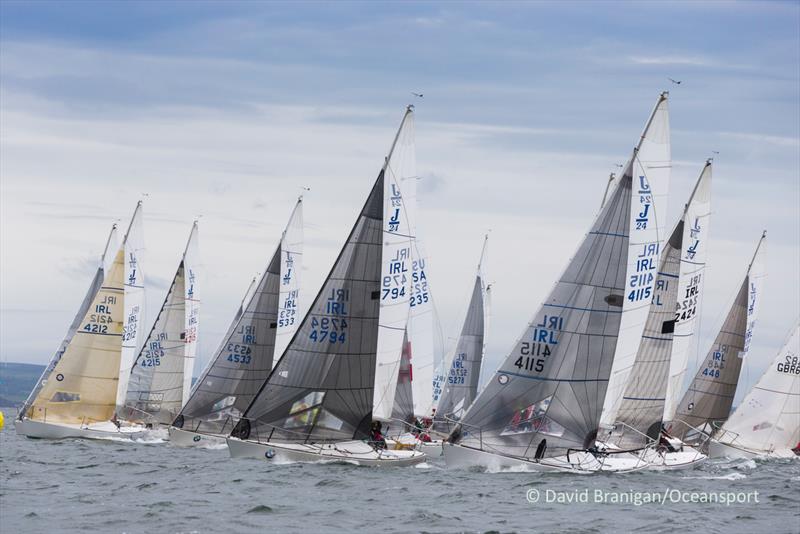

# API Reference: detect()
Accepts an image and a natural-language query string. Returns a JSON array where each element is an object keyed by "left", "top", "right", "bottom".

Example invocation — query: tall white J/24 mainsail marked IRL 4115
[{"left": 601, "top": 93, "right": 672, "bottom": 426}]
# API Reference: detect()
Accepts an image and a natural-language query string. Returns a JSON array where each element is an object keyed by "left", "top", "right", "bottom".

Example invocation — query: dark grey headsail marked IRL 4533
[{"left": 173, "top": 249, "right": 281, "bottom": 434}]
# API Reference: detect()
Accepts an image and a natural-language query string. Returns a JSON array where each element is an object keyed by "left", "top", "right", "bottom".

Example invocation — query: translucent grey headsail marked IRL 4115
[{"left": 451, "top": 172, "right": 644, "bottom": 458}]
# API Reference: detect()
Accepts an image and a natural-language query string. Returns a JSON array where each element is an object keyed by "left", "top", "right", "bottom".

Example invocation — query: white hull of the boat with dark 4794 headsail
[{"left": 227, "top": 438, "right": 426, "bottom": 467}]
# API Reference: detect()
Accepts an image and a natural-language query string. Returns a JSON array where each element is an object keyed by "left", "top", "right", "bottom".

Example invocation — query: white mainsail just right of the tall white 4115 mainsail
[{"left": 663, "top": 160, "right": 711, "bottom": 421}]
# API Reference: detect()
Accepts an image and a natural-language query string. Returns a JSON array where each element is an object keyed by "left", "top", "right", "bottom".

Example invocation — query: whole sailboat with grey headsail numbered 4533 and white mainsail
[{"left": 169, "top": 197, "right": 303, "bottom": 447}]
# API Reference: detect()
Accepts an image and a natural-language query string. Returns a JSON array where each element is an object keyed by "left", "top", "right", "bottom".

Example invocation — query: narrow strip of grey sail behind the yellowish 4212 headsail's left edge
[{"left": 19, "top": 224, "right": 121, "bottom": 419}]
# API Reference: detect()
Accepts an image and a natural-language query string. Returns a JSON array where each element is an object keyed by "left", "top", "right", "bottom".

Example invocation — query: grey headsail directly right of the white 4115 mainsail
[{"left": 611, "top": 219, "right": 684, "bottom": 448}]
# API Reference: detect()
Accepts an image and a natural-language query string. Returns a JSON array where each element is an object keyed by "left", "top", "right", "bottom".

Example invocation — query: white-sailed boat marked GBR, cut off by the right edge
[{"left": 709, "top": 324, "right": 800, "bottom": 458}]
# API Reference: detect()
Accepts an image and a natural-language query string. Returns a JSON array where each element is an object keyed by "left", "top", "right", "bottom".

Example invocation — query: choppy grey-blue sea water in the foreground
[{"left": 0, "top": 428, "right": 800, "bottom": 534}]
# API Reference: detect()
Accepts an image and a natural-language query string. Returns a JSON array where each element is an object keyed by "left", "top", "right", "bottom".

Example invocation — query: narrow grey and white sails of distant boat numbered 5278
[{"left": 436, "top": 235, "right": 489, "bottom": 426}]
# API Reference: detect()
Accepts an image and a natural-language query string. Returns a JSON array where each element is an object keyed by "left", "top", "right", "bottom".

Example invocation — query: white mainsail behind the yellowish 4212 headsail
[{"left": 117, "top": 200, "right": 145, "bottom": 415}]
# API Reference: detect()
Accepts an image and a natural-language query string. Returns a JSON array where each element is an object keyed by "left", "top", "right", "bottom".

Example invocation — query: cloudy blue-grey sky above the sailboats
[{"left": 0, "top": 1, "right": 800, "bottom": 406}]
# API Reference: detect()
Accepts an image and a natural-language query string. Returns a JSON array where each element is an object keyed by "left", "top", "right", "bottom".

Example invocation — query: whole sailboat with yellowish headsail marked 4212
[{"left": 14, "top": 201, "right": 144, "bottom": 439}]
